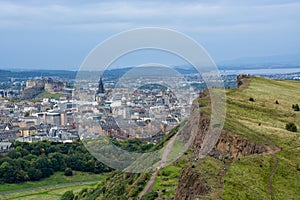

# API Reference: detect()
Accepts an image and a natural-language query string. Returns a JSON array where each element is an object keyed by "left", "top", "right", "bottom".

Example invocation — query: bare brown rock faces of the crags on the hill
[{"left": 174, "top": 88, "right": 267, "bottom": 200}]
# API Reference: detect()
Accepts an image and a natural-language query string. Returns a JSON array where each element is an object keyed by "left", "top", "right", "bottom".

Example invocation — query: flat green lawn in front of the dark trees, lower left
[{"left": 0, "top": 171, "right": 107, "bottom": 199}]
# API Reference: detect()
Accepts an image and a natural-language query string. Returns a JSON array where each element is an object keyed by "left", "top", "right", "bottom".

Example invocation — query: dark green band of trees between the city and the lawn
[{"left": 0, "top": 141, "right": 111, "bottom": 183}]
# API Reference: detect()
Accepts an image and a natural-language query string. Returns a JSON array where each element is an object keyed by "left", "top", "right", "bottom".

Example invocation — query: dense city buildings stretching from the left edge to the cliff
[{"left": 0, "top": 68, "right": 300, "bottom": 152}]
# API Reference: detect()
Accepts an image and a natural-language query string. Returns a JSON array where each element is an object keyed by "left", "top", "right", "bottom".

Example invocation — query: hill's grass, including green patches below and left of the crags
[{"left": 149, "top": 77, "right": 300, "bottom": 199}]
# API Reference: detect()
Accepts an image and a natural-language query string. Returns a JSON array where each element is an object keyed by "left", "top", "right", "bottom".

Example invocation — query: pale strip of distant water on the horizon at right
[{"left": 220, "top": 68, "right": 300, "bottom": 75}]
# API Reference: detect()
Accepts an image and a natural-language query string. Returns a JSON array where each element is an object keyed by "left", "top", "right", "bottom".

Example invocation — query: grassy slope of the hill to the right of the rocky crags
[{"left": 222, "top": 77, "right": 300, "bottom": 199}]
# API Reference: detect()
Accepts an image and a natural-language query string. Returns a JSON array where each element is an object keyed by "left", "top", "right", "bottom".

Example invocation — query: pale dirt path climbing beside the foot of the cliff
[{"left": 137, "top": 134, "right": 177, "bottom": 200}]
